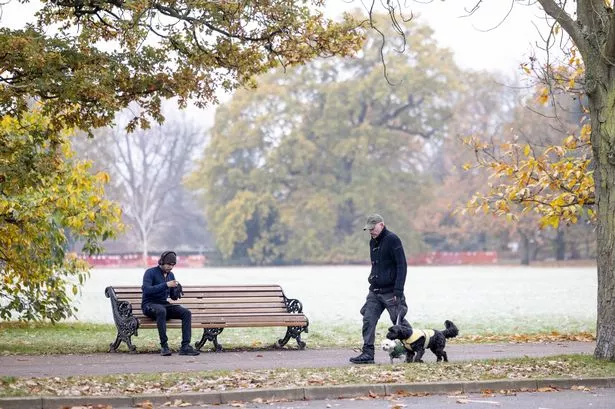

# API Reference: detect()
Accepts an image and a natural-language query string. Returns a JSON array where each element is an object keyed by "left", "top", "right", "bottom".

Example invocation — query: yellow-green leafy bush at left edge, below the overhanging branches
[{"left": 0, "top": 111, "right": 121, "bottom": 321}]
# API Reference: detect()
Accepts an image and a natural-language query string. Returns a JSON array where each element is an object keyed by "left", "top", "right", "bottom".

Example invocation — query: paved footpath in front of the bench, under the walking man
[{"left": 0, "top": 342, "right": 595, "bottom": 377}]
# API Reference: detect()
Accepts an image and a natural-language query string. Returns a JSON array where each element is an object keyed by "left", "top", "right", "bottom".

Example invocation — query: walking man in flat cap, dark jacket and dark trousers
[{"left": 350, "top": 214, "right": 410, "bottom": 364}]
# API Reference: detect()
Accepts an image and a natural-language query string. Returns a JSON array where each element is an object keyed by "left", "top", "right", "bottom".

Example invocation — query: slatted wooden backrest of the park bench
[{"left": 113, "top": 284, "right": 287, "bottom": 319}]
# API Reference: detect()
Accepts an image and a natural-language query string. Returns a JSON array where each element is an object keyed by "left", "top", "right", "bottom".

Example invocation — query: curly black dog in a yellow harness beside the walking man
[{"left": 387, "top": 320, "right": 459, "bottom": 362}]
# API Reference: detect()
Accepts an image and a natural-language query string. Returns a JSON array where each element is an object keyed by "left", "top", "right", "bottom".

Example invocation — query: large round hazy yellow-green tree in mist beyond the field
[{"left": 190, "top": 16, "right": 470, "bottom": 264}]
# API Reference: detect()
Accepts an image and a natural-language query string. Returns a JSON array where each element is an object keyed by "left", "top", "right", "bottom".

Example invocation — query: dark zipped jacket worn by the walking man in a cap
[{"left": 369, "top": 227, "right": 408, "bottom": 297}]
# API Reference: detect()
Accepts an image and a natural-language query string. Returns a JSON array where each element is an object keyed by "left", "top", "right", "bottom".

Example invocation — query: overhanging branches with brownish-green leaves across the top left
[{"left": 0, "top": 0, "right": 362, "bottom": 131}]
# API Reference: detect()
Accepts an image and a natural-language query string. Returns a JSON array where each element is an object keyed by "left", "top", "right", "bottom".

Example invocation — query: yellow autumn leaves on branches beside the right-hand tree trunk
[{"left": 464, "top": 125, "right": 595, "bottom": 227}]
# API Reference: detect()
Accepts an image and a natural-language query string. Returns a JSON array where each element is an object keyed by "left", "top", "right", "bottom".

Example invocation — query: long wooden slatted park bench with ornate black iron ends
[{"left": 105, "top": 285, "right": 309, "bottom": 352}]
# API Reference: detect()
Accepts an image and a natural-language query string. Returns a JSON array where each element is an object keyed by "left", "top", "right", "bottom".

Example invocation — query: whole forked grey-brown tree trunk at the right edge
[{"left": 538, "top": 0, "right": 615, "bottom": 361}]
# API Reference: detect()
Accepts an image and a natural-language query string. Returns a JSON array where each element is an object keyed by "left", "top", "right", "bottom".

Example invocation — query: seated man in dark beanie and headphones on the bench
[{"left": 141, "top": 251, "right": 199, "bottom": 356}]
